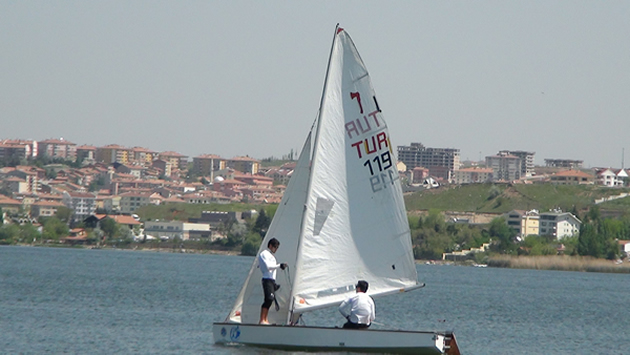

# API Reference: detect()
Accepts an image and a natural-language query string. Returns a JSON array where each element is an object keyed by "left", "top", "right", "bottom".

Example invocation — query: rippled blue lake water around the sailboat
[{"left": 0, "top": 247, "right": 630, "bottom": 355}]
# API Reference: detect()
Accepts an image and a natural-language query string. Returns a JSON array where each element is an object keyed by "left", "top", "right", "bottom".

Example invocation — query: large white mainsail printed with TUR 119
[{"left": 292, "top": 28, "right": 418, "bottom": 313}]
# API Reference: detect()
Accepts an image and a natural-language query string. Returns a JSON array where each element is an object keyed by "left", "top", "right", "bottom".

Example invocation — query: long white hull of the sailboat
[{"left": 212, "top": 323, "right": 459, "bottom": 355}]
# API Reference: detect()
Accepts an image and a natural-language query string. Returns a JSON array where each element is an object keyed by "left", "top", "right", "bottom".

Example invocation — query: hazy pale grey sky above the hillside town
[{"left": 0, "top": 0, "right": 630, "bottom": 167}]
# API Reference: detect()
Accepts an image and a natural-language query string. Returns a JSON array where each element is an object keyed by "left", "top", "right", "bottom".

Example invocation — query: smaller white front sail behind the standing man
[{"left": 228, "top": 133, "right": 311, "bottom": 324}]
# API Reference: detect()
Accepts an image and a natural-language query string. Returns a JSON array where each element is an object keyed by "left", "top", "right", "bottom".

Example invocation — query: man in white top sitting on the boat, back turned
[{"left": 339, "top": 280, "right": 376, "bottom": 329}]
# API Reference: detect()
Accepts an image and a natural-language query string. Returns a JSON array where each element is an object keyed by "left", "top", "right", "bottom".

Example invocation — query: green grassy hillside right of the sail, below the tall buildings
[{"left": 405, "top": 183, "right": 630, "bottom": 214}]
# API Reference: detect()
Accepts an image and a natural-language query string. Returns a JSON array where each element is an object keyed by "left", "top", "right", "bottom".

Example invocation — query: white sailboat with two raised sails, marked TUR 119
[{"left": 213, "top": 25, "right": 459, "bottom": 355}]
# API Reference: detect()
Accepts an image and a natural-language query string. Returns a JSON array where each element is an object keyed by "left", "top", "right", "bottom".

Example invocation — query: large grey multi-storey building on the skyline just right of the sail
[{"left": 398, "top": 143, "right": 460, "bottom": 181}]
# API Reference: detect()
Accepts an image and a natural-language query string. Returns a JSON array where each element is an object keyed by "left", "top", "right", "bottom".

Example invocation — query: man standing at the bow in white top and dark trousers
[{"left": 258, "top": 238, "right": 287, "bottom": 324}]
